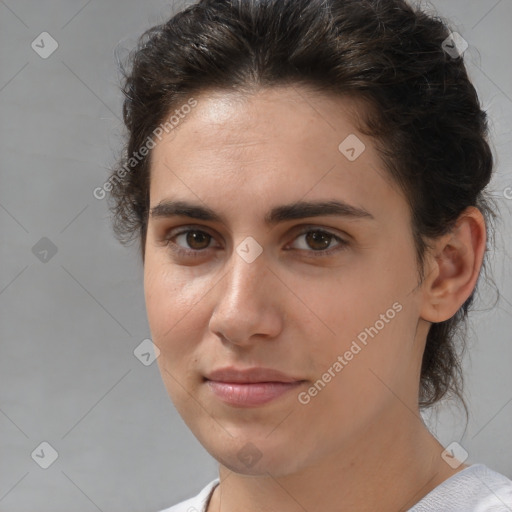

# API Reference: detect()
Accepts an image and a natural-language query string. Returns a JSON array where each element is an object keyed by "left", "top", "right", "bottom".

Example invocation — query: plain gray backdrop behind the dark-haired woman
[{"left": 0, "top": 0, "right": 512, "bottom": 512}]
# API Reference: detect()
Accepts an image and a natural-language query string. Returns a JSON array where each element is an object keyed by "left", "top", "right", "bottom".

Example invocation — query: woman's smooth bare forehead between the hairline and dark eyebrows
[{"left": 146, "top": 86, "right": 402, "bottom": 222}]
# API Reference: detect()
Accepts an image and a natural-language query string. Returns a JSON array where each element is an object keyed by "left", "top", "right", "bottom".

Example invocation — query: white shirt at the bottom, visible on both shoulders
[{"left": 160, "top": 464, "right": 512, "bottom": 512}]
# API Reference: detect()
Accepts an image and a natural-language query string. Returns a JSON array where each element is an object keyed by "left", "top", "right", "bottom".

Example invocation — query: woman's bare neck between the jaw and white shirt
[{"left": 208, "top": 404, "right": 466, "bottom": 512}]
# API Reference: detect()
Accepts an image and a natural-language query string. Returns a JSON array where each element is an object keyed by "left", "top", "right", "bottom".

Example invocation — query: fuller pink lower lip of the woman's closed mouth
[{"left": 206, "top": 380, "right": 302, "bottom": 407}]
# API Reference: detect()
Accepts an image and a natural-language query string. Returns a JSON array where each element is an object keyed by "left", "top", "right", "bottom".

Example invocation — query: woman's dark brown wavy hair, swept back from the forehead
[{"left": 108, "top": 0, "right": 496, "bottom": 407}]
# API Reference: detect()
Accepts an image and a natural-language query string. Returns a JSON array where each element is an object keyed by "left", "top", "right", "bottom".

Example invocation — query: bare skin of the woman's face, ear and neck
[{"left": 144, "top": 86, "right": 486, "bottom": 512}]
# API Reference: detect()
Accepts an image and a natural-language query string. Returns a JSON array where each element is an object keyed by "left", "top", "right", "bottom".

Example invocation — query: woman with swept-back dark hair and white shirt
[{"left": 109, "top": 0, "right": 512, "bottom": 512}]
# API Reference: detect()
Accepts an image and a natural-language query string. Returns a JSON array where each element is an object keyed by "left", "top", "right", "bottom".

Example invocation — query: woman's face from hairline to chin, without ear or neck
[{"left": 144, "top": 87, "right": 428, "bottom": 476}]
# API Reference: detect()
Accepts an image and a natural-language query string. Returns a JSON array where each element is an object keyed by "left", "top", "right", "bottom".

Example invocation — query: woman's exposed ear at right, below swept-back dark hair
[{"left": 420, "top": 206, "right": 487, "bottom": 323}]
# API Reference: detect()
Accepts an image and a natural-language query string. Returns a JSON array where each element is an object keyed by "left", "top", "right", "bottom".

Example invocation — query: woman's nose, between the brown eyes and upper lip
[{"left": 209, "top": 241, "right": 285, "bottom": 346}]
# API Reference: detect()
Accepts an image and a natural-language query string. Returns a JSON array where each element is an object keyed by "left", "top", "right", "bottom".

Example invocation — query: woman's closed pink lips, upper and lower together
[{"left": 205, "top": 367, "right": 305, "bottom": 407}]
